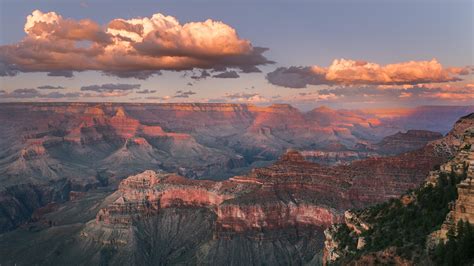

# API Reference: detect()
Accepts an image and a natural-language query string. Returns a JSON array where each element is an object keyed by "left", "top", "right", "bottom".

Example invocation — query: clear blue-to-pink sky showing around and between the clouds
[{"left": 0, "top": 0, "right": 474, "bottom": 107}]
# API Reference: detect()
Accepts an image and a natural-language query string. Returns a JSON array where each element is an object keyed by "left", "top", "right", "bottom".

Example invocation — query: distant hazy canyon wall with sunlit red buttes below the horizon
[{"left": 0, "top": 103, "right": 468, "bottom": 234}]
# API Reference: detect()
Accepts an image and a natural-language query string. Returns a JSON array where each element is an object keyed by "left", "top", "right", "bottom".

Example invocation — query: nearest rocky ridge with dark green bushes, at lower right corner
[{"left": 323, "top": 114, "right": 474, "bottom": 265}]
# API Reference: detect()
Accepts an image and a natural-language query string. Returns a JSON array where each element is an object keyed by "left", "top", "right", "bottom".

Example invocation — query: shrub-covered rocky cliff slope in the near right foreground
[{"left": 323, "top": 114, "right": 474, "bottom": 265}]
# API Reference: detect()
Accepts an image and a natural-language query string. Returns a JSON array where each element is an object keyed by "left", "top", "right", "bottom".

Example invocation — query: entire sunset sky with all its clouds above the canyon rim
[{"left": 0, "top": 0, "right": 474, "bottom": 109}]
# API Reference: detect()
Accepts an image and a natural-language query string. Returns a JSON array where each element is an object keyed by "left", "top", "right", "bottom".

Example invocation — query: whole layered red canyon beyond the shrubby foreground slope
[{"left": 0, "top": 103, "right": 472, "bottom": 265}]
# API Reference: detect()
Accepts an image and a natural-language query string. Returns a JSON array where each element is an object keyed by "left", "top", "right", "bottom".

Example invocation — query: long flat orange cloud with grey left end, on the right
[{"left": 266, "top": 59, "right": 469, "bottom": 88}]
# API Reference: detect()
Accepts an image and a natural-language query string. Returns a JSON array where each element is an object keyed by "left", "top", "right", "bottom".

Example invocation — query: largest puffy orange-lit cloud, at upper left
[{"left": 0, "top": 10, "right": 273, "bottom": 79}]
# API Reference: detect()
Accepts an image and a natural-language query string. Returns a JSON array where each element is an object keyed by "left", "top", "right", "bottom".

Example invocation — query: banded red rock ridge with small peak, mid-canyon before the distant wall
[{"left": 84, "top": 131, "right": 445, "bottom": 262}]
